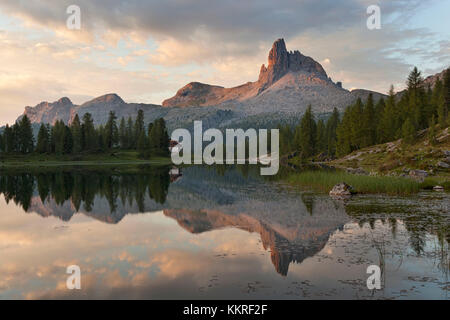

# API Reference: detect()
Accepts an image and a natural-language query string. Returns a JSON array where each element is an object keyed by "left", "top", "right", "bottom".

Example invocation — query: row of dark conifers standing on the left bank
[{"left": 0, "top": 110, "right": 169, "bottom": 158}]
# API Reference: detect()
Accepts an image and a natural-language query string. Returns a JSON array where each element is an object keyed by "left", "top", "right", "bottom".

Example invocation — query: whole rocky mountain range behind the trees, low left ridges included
[{"left": 15, "top": 39, "right": 448, "bottom": 130}]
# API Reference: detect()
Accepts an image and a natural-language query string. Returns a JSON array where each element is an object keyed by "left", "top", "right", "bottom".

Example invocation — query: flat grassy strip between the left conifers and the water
[{"left": 0, "top": 151, "right": 172, "bottom": 168}]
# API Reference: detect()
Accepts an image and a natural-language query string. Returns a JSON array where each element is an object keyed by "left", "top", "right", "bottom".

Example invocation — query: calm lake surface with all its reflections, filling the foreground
[{"left": 0, "top": 167, "right": 450, "bottom": 300}]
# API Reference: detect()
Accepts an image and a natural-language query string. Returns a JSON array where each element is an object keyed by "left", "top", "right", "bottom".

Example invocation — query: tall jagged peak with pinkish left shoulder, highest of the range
[{"left": 162, "top": 39, "right": 381, "bottom": 114}]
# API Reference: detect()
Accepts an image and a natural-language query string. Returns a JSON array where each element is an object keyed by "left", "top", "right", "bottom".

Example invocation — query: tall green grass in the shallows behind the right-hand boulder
[{"left": 287, "top": 171, "right": 420, "bottom": 195}]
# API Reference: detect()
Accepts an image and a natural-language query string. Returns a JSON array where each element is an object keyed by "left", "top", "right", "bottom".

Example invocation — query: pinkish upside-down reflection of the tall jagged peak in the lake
[{"left": 164, "top": 195, "right": 348, "bottom": 276}]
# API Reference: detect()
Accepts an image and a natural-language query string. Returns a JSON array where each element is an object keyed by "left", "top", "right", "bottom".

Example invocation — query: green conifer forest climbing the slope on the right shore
[{"left": 279, "top": 68, "right": 450, "bottom": 159}]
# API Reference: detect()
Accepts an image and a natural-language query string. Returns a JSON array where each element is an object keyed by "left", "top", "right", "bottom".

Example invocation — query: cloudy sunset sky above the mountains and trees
[{"left": 0, "top": 0, "right": 450, "bottom": 125}]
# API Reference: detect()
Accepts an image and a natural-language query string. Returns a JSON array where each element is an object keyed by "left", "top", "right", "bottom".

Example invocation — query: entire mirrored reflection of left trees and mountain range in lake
[{"left": 0, "top": 167, "right": 349, "bottom": 275}]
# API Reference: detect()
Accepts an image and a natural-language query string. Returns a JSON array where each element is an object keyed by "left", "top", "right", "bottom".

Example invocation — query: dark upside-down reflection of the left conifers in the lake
[{"left": 0, "top": 167, "right": 170, "bottom": 213}]
